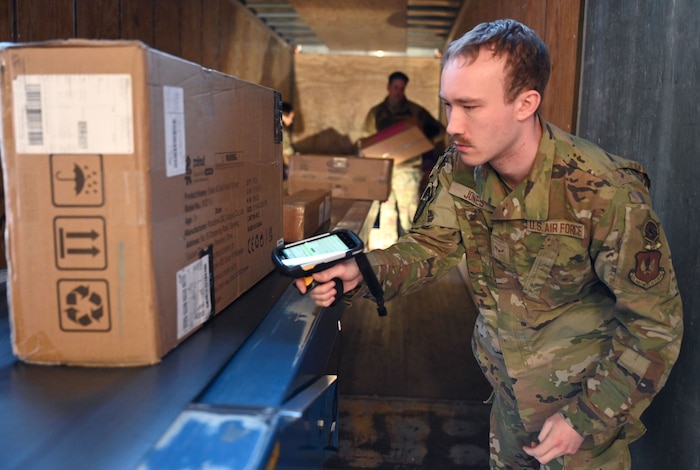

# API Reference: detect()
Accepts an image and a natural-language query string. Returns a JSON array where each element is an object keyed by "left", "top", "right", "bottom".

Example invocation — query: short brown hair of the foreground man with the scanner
[{"left": 442, "top": 19, "right": 550, "bottom": 103}]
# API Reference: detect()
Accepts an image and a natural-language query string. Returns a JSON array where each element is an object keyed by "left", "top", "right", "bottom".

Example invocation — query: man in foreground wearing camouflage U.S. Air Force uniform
[{"left": 296, "top": 20, "right": 683, "bottom": 470}]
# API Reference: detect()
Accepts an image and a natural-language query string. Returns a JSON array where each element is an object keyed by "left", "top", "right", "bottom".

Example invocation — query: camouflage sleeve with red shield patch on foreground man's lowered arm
[{"left": 562, "top": 183, "right": 683, "bottom": 444}]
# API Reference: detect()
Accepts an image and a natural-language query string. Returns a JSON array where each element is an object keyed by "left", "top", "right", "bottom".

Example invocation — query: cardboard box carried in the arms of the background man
[{"left": 360, "top": 122, "right": 435, "bottom": 165}]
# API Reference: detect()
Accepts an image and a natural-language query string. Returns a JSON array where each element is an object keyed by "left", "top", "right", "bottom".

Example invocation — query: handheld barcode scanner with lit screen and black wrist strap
[{"left": 272, "top": 229, "right": 386, "bottom": 316}]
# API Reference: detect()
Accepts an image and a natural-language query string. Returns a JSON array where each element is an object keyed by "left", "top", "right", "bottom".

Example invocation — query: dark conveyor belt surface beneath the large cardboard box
[{"left": 0, "top": 273, "right": 290, "bottom": 470}]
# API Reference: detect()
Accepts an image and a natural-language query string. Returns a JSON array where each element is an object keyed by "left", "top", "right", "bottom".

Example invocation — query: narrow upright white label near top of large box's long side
[{"left": 163, "top": 86, "right": 186, "bottom": 177}]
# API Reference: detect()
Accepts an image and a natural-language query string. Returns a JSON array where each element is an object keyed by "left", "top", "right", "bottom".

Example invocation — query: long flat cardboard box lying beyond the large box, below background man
[{"left": 287, "top": 154, "right": 394, "bottom": 201}]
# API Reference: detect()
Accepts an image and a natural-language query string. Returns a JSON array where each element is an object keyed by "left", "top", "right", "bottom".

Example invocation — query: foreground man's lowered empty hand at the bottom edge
[{"left": 523, "top": 413, "right": 583, "bottom": 464}]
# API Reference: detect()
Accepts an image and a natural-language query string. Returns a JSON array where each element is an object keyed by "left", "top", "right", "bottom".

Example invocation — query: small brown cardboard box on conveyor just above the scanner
[{"left": 282, "top": 189, "right": 331, "bottom": 243}]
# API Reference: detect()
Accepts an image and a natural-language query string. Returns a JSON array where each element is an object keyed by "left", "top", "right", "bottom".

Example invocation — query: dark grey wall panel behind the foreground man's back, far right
[{"left": 579, "top": 0, "right": 700, "bottom": 469}]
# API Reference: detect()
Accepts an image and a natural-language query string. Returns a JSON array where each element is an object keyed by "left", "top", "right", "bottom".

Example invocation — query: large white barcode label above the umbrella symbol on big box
[{"left": 12, "top": 74, "right": 134, "bottom": 154}]
